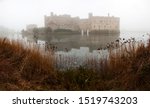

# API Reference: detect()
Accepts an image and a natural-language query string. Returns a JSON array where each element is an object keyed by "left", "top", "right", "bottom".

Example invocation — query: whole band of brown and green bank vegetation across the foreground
[{"left": 0, "top": 39, "right": 150, "bottom": 90}]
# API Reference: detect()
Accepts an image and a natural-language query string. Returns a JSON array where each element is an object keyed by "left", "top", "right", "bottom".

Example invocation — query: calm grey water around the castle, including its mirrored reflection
[{"left": 1, "top": 32, "right": 149, "bottom": 68}]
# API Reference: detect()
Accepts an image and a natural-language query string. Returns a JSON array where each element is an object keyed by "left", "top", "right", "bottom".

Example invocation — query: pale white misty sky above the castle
[{"left": 0, "top": 0, "right": 150, "bottom": 31}]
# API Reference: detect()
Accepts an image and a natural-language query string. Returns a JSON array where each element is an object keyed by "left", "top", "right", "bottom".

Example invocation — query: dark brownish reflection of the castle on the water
[{"left": 23, "top": 34, "right": 119, "bottom": 52}]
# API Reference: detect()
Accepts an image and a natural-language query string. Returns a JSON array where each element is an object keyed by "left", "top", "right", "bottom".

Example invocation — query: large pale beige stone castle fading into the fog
[{"left": 44, "top": 12, "right": 120, "bottom": 34}]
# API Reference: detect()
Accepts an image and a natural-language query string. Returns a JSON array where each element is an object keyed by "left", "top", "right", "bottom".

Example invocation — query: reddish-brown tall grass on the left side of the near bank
[{"left": 0, "top": 38, "right": 56, "bottom": 90}]
